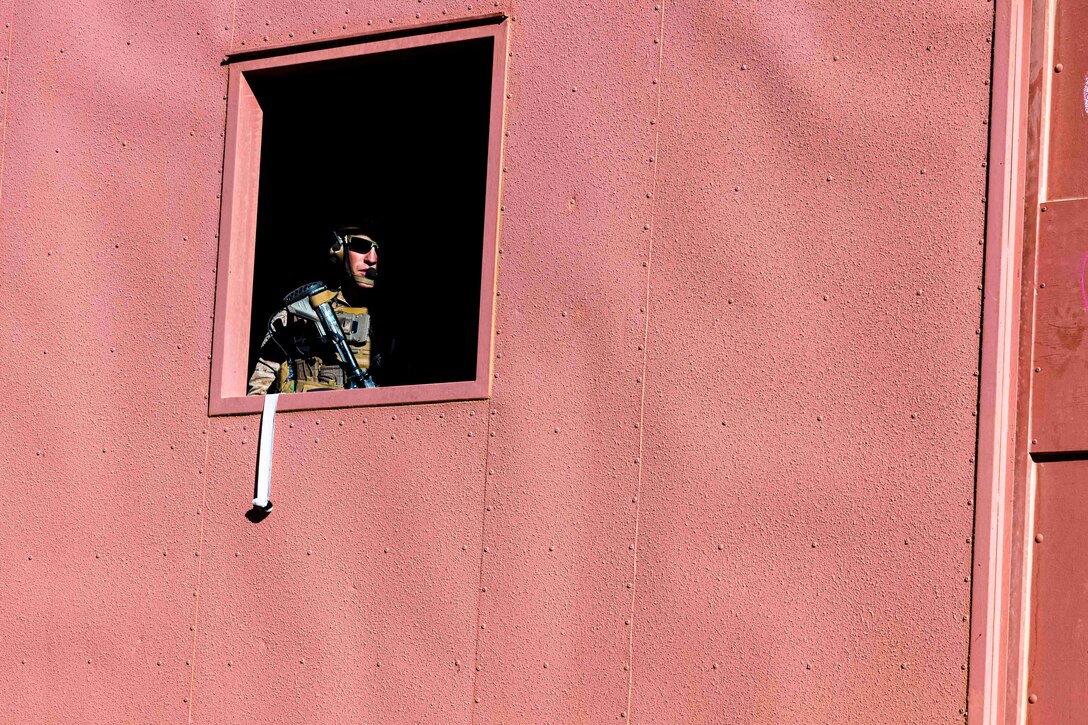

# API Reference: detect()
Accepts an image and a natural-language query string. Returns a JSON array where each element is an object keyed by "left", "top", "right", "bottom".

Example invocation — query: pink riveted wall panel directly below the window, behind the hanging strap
[{"left": 194, "top": 403, "right": 487, "bottom": 723}]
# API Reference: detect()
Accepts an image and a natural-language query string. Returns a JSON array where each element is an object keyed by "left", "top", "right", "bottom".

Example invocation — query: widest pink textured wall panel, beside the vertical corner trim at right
[{"left": 632, "top": 2, "right": 990, "bottom": 723}]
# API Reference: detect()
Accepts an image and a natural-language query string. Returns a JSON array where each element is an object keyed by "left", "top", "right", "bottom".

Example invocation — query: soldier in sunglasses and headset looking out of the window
[{"left": 247, "top": 226, "right": 382, "bottom": 395}]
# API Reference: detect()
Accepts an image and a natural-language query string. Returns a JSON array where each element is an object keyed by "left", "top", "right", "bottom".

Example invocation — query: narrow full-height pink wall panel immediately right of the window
[{"left": 465, "top": 3, "right": 658, "bottom": 709}]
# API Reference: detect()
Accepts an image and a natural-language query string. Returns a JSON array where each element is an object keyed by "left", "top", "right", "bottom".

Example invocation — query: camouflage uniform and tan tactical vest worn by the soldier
[{"left": 246, "top": 292, "right": 381, "bottom": 395}]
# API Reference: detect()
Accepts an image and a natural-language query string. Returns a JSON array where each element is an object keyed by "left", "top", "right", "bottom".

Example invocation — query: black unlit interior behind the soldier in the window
[{"left": 247, "top": 38, "right": 493, "bottom": 385}]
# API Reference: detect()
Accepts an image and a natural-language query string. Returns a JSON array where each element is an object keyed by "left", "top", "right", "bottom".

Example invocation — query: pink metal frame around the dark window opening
[{"left": 208, "top": 16, "right": 508, "bottom": 416}]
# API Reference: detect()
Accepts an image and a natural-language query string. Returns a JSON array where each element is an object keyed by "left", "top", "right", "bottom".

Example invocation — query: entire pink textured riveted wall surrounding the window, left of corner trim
[{"left": 0, "top": 0, "right": 993, "bottom": 723}]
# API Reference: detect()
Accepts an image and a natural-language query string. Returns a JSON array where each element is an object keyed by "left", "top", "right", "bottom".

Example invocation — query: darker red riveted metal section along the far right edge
[{"left": 1014, "top": 2, "right": 1088, "bottom": 709}]
